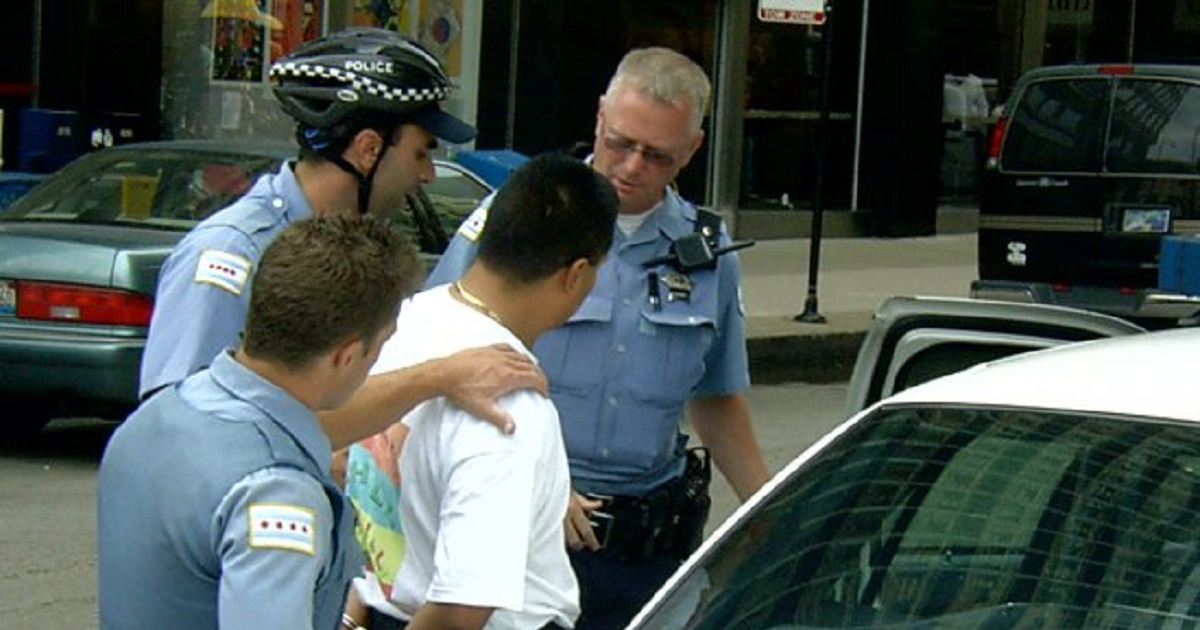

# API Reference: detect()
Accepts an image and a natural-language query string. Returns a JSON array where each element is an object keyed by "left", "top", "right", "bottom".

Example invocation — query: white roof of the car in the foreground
[{"left": 881, "top": 328, "right": 1200, "bottom": 422}]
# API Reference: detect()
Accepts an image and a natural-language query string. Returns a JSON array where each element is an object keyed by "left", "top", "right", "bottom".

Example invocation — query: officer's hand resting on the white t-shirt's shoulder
[{"left": 440, "top": 343, "right": 550, "bottom": 433}]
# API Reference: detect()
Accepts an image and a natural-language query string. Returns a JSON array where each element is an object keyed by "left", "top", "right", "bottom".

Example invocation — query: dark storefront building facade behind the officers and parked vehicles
[{"left": 7, "top": 0, "right": 1200, "bottom": 238}]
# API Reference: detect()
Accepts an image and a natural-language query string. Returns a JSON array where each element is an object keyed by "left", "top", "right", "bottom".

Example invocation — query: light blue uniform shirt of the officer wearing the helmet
[{"left": 138, "top": 164, "right": 313, "bottom": 397}]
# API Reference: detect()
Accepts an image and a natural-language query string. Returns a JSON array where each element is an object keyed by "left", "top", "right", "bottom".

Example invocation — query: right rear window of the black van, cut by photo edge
[{"left": 1105, "top": 78, "right": 1200, "bottom": 174}]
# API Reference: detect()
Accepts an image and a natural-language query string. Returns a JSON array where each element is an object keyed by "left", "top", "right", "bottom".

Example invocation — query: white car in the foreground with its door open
[{"left": 630, "top": 299, "right": 1200, "bottom": 630}]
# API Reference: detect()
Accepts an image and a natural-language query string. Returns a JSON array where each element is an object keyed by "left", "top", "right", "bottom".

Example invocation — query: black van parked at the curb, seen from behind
[{"left": 971, "top": 65, "right": 1200, "bottom": 323}]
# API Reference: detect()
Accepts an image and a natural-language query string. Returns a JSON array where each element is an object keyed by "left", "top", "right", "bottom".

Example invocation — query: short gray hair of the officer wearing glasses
[{"left": 605, "top": 47, "right": 713, "bottom": 131}]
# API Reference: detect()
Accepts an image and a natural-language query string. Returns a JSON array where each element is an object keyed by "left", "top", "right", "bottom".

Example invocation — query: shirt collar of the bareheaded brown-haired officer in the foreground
[{"left": 209, "top": 350, "right": 332, "bottom": 474}]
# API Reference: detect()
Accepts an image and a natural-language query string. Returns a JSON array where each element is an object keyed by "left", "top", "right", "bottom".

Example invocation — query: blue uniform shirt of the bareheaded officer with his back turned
[{"left": 96, "top": 353, "right": 362, "bottom": 630}]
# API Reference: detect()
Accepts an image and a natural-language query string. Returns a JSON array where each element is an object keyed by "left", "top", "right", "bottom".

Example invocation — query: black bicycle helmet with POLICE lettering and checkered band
[{"left": 270, "top": 29, "right": 451, "bottom": 128}]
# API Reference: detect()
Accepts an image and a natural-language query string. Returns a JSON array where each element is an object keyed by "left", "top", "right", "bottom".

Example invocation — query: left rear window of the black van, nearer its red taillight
[{"left": 1001, "top": 78, "right": 1109, "bottom": 173}]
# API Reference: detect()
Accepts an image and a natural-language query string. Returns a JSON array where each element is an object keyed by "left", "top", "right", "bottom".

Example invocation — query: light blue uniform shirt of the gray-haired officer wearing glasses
[{"left": 426, "top": 184, "right": 750, "bottom": 496}]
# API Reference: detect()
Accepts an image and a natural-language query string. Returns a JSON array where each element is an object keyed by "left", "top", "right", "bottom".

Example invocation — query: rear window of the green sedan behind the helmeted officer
[{"left": 0, "top": 149, "right": 280, "bottom": 230}]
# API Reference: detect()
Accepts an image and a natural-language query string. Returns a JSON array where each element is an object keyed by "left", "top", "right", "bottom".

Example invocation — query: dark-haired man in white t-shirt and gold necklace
[{"left": 367, "top": 154, "right": 618, "bottom": 630}]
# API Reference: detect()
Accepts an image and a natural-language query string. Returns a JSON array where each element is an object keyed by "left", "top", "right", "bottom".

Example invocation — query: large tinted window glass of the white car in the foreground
[{"left": 638, "top": 408, "right": 1200, "bottom": 630}]
